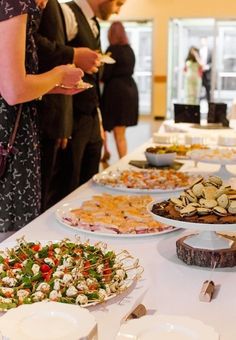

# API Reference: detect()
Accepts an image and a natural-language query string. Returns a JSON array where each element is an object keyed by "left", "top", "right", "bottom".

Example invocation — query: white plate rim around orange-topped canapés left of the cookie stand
[{"left": 55, "top": 197, "right": 179, "bottom": 239}]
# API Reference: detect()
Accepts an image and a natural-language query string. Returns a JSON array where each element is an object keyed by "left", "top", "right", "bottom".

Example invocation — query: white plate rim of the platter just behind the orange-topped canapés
[{"left": 92, "top": 171, "right": 190, "bottom": 194}]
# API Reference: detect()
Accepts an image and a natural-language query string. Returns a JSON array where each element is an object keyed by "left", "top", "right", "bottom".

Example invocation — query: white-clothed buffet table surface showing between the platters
[{"left": 1, "top": 141, "right": 236, "bottom": 340}]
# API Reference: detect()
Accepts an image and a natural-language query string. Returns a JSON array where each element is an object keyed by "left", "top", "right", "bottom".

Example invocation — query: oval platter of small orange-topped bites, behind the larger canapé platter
[{"left": 93, "top": 169, "right": 195, "bottom": 194}]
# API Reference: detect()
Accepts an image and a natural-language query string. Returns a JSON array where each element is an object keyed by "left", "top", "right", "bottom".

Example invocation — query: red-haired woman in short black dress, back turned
[{"left": 101, "top": 21, "right": 138, "bottom": 161}]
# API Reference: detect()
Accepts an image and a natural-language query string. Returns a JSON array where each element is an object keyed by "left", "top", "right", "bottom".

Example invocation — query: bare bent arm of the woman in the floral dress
[{"left": 0, "top": 14, "right": 83, "bottom": 105}]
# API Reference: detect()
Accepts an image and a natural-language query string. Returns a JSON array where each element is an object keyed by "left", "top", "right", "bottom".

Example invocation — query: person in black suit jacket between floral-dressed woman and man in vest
[{"left": 35, "top": 0, "right": 100, "bottom": 211}]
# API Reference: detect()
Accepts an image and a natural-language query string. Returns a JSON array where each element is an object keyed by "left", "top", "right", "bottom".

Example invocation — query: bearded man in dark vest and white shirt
[{"left": 62, "top": 0, "right": 126, "bottom": 190}]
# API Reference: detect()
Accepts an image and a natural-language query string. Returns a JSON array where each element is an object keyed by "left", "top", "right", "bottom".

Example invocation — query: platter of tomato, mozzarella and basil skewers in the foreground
[{"left": 0, "top": 238, "right": 142, "bottom": 311}]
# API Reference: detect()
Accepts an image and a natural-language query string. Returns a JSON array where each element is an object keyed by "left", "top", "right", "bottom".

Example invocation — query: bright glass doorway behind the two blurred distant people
[{"left": 167, "top": 18, "right": 236, "bottom": 118}]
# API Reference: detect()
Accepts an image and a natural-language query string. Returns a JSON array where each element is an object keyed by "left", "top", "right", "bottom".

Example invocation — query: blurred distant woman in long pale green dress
[{"left": 184, "top": 46, "right": 202, "bottom": 105}]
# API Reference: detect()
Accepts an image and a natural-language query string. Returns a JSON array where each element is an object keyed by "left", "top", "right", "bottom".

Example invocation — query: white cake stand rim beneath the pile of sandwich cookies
[{"left": 147, "top": 200, "right": 236, "bottom": 231}]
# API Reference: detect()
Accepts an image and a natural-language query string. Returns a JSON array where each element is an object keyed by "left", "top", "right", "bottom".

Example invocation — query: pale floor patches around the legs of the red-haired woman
[{"left": 101, "top": 117, "right": 162, "bottom": 170}]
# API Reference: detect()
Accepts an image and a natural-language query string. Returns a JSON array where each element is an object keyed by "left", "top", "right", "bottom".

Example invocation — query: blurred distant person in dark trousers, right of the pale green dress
[{"left": 199, "top": 37, "right": 212, "bottom": 103}]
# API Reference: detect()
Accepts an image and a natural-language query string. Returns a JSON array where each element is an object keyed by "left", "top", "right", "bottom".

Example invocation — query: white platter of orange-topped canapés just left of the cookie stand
[{"left": 55, "top": 193, "right": 177, "bottom": 238}]
